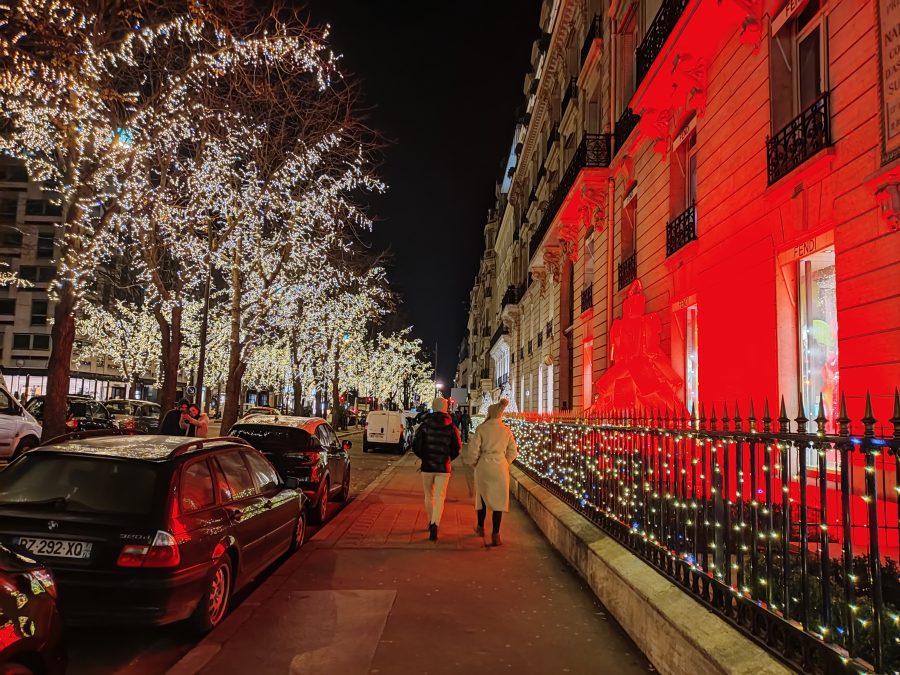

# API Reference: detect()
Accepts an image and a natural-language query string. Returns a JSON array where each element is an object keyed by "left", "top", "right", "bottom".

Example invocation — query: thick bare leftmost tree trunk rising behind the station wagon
[{"left": 41, "top": 282, "right": 76, "bottom": 441}]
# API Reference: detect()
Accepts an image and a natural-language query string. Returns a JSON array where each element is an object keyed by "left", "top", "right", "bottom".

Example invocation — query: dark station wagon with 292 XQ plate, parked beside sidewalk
[{"left": 0, "top": 432, "right": 306, "bottom": 631}]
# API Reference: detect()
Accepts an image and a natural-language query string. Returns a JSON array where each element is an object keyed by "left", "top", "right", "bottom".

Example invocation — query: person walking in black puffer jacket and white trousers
[{"left": 413, "top": 396, "right": 462, "bottom": 541}]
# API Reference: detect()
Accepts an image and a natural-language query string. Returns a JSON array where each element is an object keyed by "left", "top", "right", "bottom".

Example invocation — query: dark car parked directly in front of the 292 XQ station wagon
[{"left": 229, "top": 415, "right": 353, "bottom": 523}]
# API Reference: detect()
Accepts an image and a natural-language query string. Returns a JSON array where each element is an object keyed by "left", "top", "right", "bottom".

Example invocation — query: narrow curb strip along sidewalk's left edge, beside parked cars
[{"left": 166, "top": 453, "right": 413, "bottom": 675}]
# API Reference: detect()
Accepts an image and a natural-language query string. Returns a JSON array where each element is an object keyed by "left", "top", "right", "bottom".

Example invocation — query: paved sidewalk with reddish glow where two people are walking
[{"left": 169, "top": 455, "right": 650, "bottom": 675}]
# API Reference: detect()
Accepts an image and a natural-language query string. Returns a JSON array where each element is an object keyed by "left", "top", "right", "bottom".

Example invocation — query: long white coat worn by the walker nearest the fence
[{"left": 469, "top": 418, "right": 519, "bottom": 511}]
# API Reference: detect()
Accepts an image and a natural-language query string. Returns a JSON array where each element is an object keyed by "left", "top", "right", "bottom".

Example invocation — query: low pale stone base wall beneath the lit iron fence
[{"left": 510, "top": 466, "right": 794, "bottom": 675}]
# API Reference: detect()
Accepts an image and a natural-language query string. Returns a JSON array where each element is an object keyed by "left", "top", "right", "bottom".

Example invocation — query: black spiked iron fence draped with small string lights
[{"left": 509, "top": 390, "right": 900, "bottom": 675}]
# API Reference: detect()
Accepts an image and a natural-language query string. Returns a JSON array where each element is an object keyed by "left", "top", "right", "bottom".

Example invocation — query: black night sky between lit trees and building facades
[{"left": 306, "top": 0, "right": 541, "bottom": 393}]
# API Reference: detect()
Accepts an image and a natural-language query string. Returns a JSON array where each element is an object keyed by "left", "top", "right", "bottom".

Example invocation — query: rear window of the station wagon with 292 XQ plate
[{"left": 0, "top": 452, "right": 158, "bottom": 515}]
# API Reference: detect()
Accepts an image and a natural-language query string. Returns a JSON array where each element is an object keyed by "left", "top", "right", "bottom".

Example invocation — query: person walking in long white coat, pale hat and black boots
[{"left": 469, "top": 399, "right": 519, "bottom": 546}]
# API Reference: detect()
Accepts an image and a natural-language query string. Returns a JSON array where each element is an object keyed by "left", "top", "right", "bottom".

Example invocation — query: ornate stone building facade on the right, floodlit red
[{"left": 469, "top": 0, "right": 900, "bottom": 428}]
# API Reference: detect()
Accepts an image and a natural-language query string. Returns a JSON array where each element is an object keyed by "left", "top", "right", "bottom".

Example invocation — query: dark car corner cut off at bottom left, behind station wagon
[{"left": 0, "top": 545, "right": 66, "bottom": 675}]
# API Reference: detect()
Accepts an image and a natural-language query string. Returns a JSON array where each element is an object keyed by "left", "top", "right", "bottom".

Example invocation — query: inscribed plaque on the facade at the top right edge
[{"left": 877, "top": 0, "right": 900, "bottom": 164}]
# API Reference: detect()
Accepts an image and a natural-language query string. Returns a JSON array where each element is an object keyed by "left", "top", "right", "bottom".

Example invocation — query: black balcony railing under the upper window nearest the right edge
[{"left": 766, "top": 91, "right": 831, "bottom": 185}]
